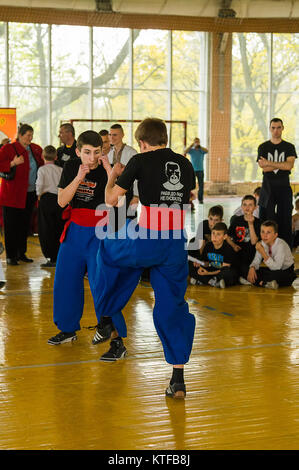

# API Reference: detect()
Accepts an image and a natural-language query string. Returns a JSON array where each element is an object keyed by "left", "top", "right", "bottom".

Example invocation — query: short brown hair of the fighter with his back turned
[{"left": 135, "top": 118, "right": 168, "bottom": 147}]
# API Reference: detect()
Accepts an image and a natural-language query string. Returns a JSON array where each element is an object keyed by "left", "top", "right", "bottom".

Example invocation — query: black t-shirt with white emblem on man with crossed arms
[{"left": 257, "top": 140, "right": 297, "bottom": 186}]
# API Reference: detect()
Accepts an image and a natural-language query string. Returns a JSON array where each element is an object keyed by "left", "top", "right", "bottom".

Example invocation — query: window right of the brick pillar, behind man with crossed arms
[{"left": 231, "top": 33, "right": 299, "bottom": 181}]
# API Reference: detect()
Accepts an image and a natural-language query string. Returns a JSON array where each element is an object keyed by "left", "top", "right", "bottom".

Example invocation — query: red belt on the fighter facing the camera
[{"left": 60, "top": 206, "right": 109, "bottom": 243}]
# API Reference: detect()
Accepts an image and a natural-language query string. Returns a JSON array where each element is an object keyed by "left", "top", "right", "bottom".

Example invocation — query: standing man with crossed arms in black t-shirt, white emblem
[{"left": 257, "top": 118, "right": 297, "bottom": 248}]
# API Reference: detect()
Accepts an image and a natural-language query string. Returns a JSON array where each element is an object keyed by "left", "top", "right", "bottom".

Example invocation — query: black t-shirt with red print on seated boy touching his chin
[{"left": 228, "top": 215, "right": 261, "bottom": 262}]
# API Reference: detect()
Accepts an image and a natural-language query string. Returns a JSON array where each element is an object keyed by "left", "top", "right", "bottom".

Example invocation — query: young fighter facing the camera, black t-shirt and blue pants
[{"left": 48, "top": 131, "right": 113, "bottom": 345}]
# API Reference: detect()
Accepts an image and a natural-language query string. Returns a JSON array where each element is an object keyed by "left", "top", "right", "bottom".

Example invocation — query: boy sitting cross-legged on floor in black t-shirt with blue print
[{"left": 195, "top": 222, "right": 238, "bottom": 289}]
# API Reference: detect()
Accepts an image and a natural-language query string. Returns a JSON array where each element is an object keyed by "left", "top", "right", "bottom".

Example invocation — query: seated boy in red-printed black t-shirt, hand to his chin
[{"left": 228, "top": 194, "right": 261, "bottom": 284}]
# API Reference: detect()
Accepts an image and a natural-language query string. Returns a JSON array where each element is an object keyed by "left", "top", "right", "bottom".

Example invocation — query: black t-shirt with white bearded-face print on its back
[{"left": 116, "top": 148, "right": 195, "bottom": 207}]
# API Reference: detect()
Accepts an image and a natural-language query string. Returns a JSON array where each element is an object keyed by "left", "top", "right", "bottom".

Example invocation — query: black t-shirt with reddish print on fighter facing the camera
[{"left": 58, "top": 157, "right": 107, "bottom": 209}]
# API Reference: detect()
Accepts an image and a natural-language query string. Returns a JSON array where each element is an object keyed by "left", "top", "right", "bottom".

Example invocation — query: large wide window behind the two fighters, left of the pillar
[{"left": 0, "top": 22, "right": 207, "bottom": 152}]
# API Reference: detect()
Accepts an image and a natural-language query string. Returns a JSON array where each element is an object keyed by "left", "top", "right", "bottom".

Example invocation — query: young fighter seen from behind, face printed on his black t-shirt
[{"left": 97, "top": 118, "right": 195, "bottom": 398}]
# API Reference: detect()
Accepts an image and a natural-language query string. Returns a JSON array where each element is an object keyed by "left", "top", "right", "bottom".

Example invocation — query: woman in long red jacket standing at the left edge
[{"left": 0, "top": 124, "right": 43, "bottom": 265}]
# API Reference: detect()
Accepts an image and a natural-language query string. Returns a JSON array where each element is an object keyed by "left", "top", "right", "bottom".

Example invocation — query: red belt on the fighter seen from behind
[{"left": 138, "top": 206, "right": 186, "bottom": 230}]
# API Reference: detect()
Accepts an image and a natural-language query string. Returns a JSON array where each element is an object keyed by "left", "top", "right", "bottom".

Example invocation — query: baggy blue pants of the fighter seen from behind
[{"left": 95, "top": 222, "right": 195, "bottom": 365}]
